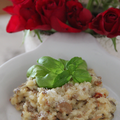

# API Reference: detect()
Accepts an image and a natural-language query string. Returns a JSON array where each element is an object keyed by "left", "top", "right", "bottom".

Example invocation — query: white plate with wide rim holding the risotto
[{"left": 0, "top": 33, "right": 120, "bottom": 120}]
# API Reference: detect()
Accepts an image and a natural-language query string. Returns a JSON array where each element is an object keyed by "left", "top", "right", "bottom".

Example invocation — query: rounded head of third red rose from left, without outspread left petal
[{"left": 67, "top": 1, "right": 93, "bottom": 31}]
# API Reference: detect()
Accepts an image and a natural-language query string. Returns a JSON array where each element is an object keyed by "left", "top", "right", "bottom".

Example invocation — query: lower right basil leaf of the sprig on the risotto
[{"left": 72, "top": 69, "right": 92, "bottom": 83}]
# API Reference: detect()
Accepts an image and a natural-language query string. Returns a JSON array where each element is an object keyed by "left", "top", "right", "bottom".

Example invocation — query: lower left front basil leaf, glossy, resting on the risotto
[{"left": 36, "top": 72, "right": 57, "bottom": 88}]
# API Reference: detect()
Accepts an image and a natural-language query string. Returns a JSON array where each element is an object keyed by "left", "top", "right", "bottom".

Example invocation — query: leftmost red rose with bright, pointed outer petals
[{"left": 4, "top": 0, "right": 51, "bottom": 33}]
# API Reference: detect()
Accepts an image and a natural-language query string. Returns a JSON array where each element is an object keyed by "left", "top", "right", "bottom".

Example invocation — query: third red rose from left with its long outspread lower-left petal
[{"left": 51, "top": 0, "right": 92, "bottom": 32}]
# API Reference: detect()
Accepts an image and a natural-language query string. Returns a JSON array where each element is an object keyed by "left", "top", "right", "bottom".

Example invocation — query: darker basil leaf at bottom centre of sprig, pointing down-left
[{"left": 53, "top": 70, "right": 71, "bottom": 88}]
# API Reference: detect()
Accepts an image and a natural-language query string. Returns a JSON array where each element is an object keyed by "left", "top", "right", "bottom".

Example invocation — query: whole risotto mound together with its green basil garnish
[{"left": 10, "top": 56, "right": 116, "bottom": 120}]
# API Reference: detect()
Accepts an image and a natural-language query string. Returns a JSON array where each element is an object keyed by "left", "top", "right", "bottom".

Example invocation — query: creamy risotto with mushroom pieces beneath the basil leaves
[{"left": 10, "top": 69, "right": 116, "bottom": 120}]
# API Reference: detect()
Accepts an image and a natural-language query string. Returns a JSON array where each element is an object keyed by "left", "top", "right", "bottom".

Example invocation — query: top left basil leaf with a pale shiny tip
[{"left": 37, "top": 56, "right": 64, "bottom": 74}]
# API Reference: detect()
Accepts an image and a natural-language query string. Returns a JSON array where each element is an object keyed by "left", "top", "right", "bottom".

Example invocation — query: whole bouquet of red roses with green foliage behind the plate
[{"left": 4, "top": 0, "right": 120, "bottom": 51}]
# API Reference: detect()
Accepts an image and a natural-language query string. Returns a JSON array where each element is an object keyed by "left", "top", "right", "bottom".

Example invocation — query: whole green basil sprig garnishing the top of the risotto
[{"left": 27, "top": 56, "right": 92, "bottom": 88}]
